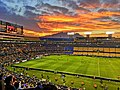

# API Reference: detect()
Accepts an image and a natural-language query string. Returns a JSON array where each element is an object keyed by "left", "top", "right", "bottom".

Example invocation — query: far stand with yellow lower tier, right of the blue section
[{"left": 74, "top": 37, "right": 120, "bottom": 57}]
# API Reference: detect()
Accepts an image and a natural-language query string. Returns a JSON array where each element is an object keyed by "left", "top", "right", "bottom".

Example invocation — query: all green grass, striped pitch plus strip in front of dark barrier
[{"left": 8, "top": 55, "right": 120, "bottom": 90}]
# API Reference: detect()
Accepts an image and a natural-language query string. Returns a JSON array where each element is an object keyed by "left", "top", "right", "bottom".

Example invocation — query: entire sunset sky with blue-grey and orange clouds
[{"left": 0, "top": 0, "right": 120, "bottom": 36}]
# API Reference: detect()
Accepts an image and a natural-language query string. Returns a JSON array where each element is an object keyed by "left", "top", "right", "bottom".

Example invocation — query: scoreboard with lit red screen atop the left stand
[{"left": 0, "top": 20, "right": 23, "bottom": 35}]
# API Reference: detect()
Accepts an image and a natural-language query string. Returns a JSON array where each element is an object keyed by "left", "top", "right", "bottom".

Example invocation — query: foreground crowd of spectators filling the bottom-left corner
[{"left": 0, "top": 68, "right": 57, "bottom": 90}]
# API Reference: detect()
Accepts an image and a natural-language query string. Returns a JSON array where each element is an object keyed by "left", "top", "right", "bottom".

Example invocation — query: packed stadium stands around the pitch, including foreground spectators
[{"left": 0, "top": 21, "right": 120, "bottom": 90}]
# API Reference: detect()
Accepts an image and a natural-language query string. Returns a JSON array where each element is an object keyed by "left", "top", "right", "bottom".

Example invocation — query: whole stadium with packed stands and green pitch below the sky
[{"left": 0, "top": 21, "right": 120, "bottom": 90}]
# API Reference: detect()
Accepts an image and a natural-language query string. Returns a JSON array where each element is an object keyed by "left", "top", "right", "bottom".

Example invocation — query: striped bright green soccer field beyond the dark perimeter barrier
[{"left": 15, "top": 55, "right": 120, "bottom": 79}]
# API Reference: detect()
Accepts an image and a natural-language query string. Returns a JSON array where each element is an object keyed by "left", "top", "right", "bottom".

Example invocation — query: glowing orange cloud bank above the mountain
[{"left": 26, "top": 11, "right": 120, "bottom": 36}]
